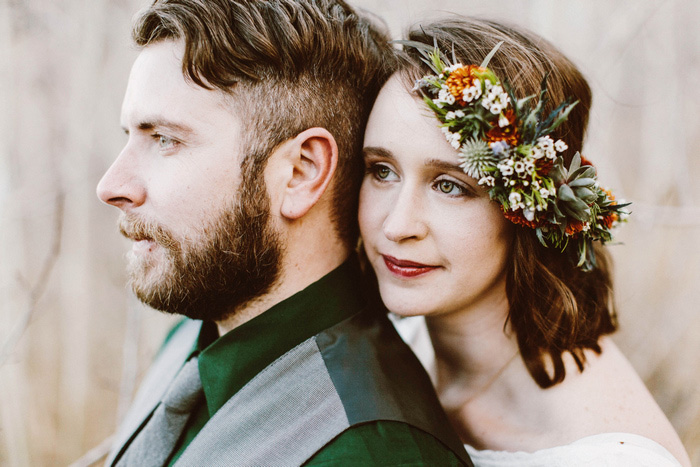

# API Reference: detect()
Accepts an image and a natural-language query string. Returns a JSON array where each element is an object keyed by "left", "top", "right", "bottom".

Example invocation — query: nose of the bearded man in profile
[{"left": 97, "top": 146, "right": 146, "bottom": 211}]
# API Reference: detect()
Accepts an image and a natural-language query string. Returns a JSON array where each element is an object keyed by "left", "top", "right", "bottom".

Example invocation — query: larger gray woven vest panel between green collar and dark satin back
[{"left": 175, "top": 337, "right": 350, "bottom": 467}]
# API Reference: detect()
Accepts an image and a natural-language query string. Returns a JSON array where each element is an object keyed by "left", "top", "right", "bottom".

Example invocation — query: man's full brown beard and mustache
[{"left": 119, "top": 168, "right": 282, "bottom": 321}]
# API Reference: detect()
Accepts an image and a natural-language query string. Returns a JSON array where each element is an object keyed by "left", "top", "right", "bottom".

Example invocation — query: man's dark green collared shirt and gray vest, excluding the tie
[{"left": 108, "top": 262, "right": 471, "bottom": 466}]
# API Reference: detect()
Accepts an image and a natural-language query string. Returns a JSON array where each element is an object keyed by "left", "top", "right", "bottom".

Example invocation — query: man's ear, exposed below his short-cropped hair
[{"left": 280, "top": 127, "right": 338, "bottom": 219}]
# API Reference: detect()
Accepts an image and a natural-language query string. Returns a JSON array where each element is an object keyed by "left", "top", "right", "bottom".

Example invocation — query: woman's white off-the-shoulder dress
[{"left": 392, "top": 316, "right": 681, "bottom": 467}]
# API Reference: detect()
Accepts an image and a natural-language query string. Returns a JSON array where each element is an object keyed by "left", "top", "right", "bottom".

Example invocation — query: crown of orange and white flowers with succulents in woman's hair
[{"left": 404, "top": 41, "right": 629, "bottom": 271}]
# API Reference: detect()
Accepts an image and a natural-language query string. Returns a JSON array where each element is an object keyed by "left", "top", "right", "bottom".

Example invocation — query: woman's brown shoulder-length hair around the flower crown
[{"left": 400, "top": 17, "right": 617, "bottom": 388}]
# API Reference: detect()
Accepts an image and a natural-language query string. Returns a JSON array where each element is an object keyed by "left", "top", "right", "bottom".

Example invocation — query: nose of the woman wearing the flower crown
[{"left": 382, "top": 187, "right": 428, "bottom": 242}]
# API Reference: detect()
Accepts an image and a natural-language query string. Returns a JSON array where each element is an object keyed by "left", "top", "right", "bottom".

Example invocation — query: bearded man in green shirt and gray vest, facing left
[{"left": 97, "top": 0, "right": 470, "bottom": 466}]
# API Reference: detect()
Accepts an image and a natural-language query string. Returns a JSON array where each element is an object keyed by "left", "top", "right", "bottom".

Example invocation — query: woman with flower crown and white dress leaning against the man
[{"left": 359, "top": 19, "right": 690, "bottom": 466}]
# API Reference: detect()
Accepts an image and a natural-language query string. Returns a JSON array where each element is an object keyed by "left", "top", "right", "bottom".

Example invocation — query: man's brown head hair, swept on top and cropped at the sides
[{"left": 133, "top": 0, "right": 394, "bottom": 245}]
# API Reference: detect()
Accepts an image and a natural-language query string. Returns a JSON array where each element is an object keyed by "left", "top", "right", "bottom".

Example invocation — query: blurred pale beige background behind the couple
[{"left": 0, "top": 0, "right": 700, "bottom": 466}]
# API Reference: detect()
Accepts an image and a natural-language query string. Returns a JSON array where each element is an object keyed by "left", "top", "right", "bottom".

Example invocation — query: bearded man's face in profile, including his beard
[{"left": 97, "top": 41, "right": 281, "bottom": 321}]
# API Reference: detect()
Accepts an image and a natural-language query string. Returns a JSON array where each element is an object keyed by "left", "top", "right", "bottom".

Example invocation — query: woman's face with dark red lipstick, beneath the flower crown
[{"left": 359, "top": 75, "right": 512, "bottom": 316}]
